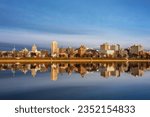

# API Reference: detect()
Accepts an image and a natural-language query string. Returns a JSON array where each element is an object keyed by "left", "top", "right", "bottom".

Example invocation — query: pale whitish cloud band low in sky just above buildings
[{"left": 0, "top": 30, "right": 150, "bottom": 49}]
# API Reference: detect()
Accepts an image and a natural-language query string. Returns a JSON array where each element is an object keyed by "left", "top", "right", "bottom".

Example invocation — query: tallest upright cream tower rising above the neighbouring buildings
[{"left": 51, "top": 41, "right": 59, "bottom": 57}]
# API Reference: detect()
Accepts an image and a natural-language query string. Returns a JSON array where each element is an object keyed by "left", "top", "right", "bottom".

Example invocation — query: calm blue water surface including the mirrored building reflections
[{"left": 0, "top": 63, "right": 150, "bottom": 100}]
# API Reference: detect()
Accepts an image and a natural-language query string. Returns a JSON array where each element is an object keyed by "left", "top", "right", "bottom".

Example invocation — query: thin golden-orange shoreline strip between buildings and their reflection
[{"left": 0, "top": 58, "right": 150, "bottom": 63}]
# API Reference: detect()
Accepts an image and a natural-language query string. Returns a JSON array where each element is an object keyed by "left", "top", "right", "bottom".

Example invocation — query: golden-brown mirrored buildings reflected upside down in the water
[{"left": 0, "top": 62, "right": 150, "bottom": 81}]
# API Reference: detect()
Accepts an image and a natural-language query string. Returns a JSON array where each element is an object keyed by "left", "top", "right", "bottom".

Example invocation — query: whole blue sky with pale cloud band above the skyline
[{"left": 0, "top": 0, "right": 150, "bottom": 49}]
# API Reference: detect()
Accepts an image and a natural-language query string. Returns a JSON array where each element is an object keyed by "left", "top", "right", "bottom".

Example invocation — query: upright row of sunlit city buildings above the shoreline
[{"left": 0, "top": 41, "right": 150, "bottom": 61}]
